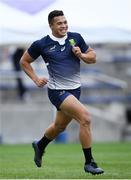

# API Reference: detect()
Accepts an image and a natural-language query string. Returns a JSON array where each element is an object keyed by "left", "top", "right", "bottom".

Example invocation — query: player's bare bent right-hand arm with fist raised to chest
[{"left": 72, "top": 46, "right": 96, "bottom": 64}]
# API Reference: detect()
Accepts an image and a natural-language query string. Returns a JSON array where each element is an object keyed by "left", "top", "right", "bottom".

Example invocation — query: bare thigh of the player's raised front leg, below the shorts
[{"left": 60, "top": 95, "right": 87, "bottom": 121}]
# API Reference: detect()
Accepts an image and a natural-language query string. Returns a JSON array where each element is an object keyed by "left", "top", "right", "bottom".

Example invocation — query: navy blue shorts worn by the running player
[{"left": 48, "top": 87, "right": 81, "bottom": 110}]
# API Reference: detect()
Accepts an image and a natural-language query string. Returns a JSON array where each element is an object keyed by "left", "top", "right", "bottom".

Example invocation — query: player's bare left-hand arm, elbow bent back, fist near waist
[{"left": 20, "top": 51, "right": 48, "bottom": 87}]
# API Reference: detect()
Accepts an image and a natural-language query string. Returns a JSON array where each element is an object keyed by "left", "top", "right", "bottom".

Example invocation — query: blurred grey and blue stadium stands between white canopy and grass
[{"left": 0, "top": 44, "right": 131, "bottom": 143}]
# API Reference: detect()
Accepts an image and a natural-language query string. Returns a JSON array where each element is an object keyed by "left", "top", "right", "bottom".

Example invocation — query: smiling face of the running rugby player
[{"left": 50, "top": 16, "right": 68, "bottom": 38}]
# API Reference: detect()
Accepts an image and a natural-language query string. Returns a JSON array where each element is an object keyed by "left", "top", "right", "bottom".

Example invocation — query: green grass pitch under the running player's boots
[{"left": 0, "top": 142, "right": 131, "bottom": 179}]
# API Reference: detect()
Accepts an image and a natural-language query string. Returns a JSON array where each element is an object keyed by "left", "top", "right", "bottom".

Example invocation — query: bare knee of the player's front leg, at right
[{"left": 80, "top": 110, "right": 91, "bottom": 127}]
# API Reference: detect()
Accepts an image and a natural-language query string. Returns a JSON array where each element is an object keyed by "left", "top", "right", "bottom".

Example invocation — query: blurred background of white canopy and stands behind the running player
[{"left": 0, "top": 0, "right": 131, "bottom": 144}]
